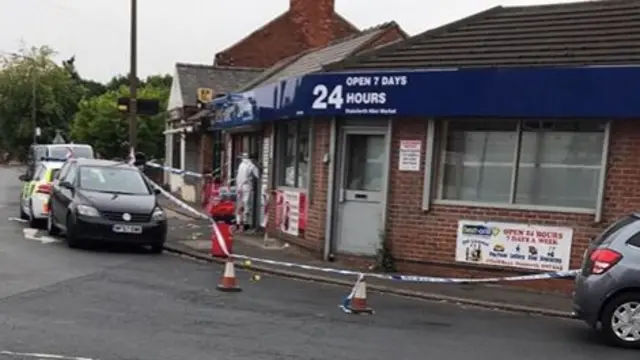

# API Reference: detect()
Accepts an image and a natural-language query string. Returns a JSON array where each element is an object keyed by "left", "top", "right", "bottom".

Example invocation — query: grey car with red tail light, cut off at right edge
[{"left": 573, "top": 213, "right": 640, "bottom": 348}]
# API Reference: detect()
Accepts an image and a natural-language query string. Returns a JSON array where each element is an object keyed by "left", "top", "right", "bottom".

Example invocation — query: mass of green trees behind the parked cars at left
[{"left": 0, "top": 42, "right": 172, "bottom": 159}]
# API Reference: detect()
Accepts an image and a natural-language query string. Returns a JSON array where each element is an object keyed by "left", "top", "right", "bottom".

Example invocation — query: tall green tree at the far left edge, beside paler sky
[{"left": 0, "top": 46, "right": 84, "bottom": 158}]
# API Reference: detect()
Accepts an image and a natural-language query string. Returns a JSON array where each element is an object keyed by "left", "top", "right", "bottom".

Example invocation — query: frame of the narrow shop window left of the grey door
[{"left": 274, "top": 119, "right": 313, "bottom": 192}]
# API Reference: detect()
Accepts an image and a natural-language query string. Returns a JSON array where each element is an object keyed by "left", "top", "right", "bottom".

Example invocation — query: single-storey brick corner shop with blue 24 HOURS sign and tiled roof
[{"left": 212, "top": 0, "right": 640, "bottom": 289}]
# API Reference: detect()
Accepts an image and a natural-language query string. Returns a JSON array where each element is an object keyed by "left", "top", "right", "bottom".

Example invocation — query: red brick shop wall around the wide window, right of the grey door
[{"left": 378, "top": 119, "right": 640, "bottom": 289}]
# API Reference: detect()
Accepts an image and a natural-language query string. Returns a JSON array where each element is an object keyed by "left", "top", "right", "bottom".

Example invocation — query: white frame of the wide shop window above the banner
[{"left": 422, "top": 119, "right": 611, "bottom": 218}]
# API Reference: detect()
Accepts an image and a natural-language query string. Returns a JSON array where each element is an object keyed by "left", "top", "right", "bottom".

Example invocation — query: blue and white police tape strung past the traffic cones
[{"left": 149, "top": 176, "right": 579, "bottom": 284}]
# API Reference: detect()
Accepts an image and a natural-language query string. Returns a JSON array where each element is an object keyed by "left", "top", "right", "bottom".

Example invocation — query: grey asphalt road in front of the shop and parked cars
[{"left": 0, "top": 168, "right": 639, "bottom": 360}]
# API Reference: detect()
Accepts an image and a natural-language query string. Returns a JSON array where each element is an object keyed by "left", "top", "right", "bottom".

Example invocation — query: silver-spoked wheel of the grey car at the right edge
[{"left": 601, "top": 292, "right": 640, "bottom": 348}]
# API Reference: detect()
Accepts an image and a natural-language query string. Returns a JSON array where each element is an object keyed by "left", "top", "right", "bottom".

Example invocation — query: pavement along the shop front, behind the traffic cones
[{"left": 161, "top": 198, "right": 573, "bottom": 318}]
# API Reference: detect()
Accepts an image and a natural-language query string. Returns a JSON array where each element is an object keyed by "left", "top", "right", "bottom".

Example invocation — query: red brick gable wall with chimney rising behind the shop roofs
[{"left": 214, "top": 0, "right": 358, "bottom": 68}]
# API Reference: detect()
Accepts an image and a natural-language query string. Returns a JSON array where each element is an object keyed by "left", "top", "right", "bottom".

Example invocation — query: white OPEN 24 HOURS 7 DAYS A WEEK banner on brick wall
[{"left": 456, "top": 220, "right": 573, "bottom": 271}]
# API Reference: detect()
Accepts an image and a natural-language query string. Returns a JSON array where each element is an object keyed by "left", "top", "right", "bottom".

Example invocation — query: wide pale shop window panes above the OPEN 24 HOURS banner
[{"left": 439, "top": 120, "right": 606, "bottom": 209}]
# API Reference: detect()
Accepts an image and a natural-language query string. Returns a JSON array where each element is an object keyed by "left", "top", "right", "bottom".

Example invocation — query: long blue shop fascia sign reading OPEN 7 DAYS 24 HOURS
[{"left": 216, "top": 66, "right": 640, "bottom": 128}]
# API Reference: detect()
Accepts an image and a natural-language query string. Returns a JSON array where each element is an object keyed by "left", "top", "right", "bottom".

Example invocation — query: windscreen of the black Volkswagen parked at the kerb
[{"left": 78, "top": 166, "right": 151, "bottom": 195}]
